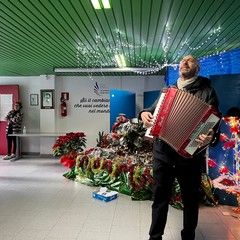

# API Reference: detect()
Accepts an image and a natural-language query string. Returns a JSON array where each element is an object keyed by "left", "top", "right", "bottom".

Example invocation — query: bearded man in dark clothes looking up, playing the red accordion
[{"left": 139, "top": 55, "right": 220, "bottom": 240}]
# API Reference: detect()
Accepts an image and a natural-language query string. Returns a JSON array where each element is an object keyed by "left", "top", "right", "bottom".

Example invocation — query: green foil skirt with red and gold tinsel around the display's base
[{"left": 64, "top": 152, "right": 217, "bottom": 204}]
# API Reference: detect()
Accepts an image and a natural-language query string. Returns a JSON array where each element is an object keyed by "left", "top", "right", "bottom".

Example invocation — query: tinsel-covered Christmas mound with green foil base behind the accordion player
[{"left": 53, "top": 117, "right": 217, "bottom": 209}]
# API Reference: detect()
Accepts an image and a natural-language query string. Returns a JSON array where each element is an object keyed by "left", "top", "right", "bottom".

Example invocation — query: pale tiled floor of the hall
[{"left": 0, "top": 157, "right": 240, "bottom": 240}]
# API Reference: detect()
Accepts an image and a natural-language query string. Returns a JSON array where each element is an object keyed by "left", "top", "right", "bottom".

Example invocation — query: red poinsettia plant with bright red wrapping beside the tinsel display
[{"left": 52, "top": 132, "right": 86, "bottom": 168}]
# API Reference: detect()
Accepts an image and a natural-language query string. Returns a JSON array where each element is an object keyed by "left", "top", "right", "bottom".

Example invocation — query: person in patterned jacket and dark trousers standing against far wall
[{"left": 3, "top": 102, "right": 23, "bottom": 160}]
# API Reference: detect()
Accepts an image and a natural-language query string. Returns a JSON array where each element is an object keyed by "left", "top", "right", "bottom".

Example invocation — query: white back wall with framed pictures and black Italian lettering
[{"left": 0, "top": 75, "right": 164, "bottom": 154}]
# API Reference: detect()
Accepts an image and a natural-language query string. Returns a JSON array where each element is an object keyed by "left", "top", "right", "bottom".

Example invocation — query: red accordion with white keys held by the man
[{"left": 145, "top": 88, "right": 221, "bottom": 158}]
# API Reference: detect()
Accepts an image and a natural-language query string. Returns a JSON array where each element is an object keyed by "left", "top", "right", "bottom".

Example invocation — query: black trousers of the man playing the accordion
[{"left": 149, "top": 159, "right": 204, "bottom": 240}]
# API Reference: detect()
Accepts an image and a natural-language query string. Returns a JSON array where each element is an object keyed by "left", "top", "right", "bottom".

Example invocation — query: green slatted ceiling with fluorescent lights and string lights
[{"left": 0, "top": 0, "right": 240, "bottom": 76}]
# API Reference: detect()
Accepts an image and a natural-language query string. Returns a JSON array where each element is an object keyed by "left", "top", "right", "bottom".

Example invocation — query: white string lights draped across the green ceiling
[{"left": 76, "top": 26, "right": 221, "bottom": 79}]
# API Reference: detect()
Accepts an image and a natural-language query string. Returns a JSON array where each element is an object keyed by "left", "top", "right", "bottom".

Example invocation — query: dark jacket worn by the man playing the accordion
[{"left": 139, "top": 76, "right": 220, "bottom": 163}]
